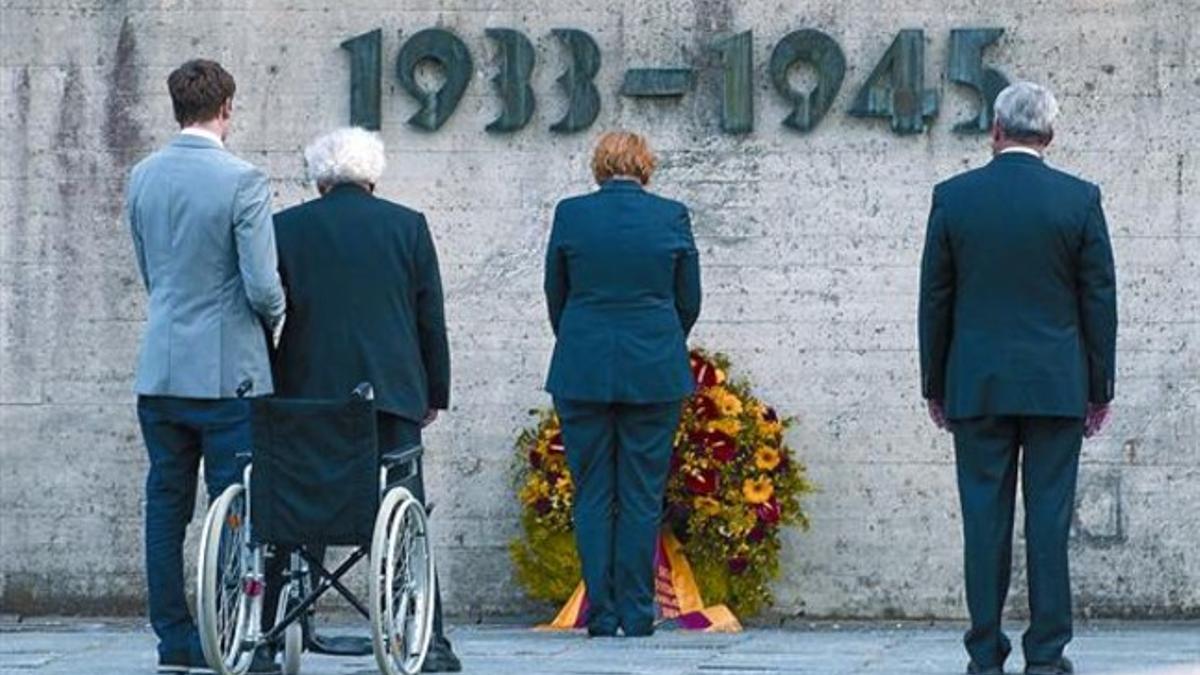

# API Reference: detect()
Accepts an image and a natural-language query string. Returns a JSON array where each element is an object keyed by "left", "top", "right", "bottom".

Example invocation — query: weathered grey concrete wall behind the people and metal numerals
[{"left": 0, "top": 0, "right": 1200, "bottom": 617}]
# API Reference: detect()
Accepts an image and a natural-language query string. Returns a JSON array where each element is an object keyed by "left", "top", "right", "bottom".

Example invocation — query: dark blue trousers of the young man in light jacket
[{"left": 138, "top": 396, "right": 251, "bottom": 658}]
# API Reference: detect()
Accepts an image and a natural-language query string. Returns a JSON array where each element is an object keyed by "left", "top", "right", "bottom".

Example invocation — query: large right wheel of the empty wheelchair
[{"left": 370, "top": 488, "right": 433, "bottom": 675}]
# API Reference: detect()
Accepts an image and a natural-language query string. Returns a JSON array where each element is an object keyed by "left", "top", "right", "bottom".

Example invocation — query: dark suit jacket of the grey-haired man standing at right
[{"left": 919, "top": 153, "right": 1117, "bottom": 419}]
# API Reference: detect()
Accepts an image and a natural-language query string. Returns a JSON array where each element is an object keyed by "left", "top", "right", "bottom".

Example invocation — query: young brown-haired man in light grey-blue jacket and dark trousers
[{"left": 126, "top": 60, "right": 284, "bottom": 673}]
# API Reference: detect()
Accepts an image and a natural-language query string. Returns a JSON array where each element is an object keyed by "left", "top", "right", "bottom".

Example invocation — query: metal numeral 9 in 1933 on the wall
[{"left": 396, "top": 28, "right": 475, "bottom": 131}]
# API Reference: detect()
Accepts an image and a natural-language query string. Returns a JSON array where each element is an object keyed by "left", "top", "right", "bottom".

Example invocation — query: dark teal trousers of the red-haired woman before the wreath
[{"left": 554, "top": 399, "right": 682, "bottom": 635}]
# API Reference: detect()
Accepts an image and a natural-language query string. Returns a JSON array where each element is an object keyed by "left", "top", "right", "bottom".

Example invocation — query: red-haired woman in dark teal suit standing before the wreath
[{"left": 545, "top": 132, "right": 700, "bottom": 637}]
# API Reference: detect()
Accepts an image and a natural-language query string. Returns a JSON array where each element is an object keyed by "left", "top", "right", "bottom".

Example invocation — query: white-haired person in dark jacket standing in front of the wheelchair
[{"left": 266, "top": 129, "right": 461, "bottom": 673}]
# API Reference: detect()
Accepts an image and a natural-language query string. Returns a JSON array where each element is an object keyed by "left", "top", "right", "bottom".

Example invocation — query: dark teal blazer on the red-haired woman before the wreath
[{"left": 545, "top": 179, "right": 701, "bottom": 404}]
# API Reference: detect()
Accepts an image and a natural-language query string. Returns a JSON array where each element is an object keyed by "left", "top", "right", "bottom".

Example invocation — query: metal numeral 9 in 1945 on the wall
[{"left": 769, "top": 29, "right": 846, "bottom": 131}]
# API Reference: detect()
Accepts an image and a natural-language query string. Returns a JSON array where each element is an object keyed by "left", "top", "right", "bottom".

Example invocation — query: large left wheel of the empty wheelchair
[{"left": 196, "top": 484, "right": 263, "bottom": 675}]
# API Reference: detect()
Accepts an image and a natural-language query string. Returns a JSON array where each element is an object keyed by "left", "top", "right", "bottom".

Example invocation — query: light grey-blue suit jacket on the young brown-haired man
[{"left": 126, "top": 135, "right": 284, "bottom": 399}]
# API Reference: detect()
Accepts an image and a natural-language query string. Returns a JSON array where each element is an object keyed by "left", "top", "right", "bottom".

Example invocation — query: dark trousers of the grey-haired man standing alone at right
[{"left": 950, "top": 417, "right": 1084, "bottom": 668}]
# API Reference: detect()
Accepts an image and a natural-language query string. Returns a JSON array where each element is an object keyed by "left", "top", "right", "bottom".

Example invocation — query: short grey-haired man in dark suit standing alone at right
[{"left": 919, "top": 82, "right": 1117, "bottom": 675}]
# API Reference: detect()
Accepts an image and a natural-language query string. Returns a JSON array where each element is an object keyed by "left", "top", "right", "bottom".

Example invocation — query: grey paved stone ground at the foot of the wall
[{"left": 0, "top": 620, "right": 1200, "bottom": 675}]
